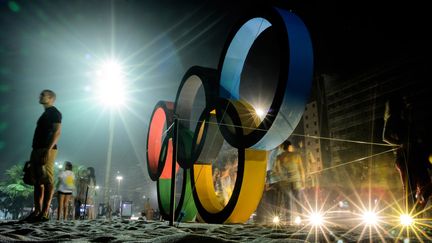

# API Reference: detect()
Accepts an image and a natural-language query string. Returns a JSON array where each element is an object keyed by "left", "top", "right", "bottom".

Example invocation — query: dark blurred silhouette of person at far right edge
[{"left": 383, "top": 95, "right": 432, "bottom": 214}]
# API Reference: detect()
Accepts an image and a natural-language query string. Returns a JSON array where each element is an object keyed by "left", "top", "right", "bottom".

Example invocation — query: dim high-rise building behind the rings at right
[{"left": 324, "top": 55, "right": 431, "bottom": 196}]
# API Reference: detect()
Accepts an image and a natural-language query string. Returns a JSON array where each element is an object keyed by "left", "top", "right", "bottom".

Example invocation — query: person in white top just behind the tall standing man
[{"left": 57, "top": 161, "right": 75, "bottom": 220}]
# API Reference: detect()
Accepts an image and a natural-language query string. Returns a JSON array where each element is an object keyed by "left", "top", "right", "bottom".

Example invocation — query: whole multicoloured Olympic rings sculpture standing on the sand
[{"left": 147, "top": 5, "right": 313, "bottom": 223}]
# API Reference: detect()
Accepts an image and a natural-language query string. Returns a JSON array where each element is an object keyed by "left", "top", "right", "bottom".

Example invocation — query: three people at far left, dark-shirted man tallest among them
[{"left": 22, "top": 89, "right": 96, "bottom": 223}]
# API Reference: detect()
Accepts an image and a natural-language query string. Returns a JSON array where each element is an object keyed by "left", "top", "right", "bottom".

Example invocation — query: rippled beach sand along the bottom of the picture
[{"left": 0, "top": 219, "right": 431, "bottom": 243}]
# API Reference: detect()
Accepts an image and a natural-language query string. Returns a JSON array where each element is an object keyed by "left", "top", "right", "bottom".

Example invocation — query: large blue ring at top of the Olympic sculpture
[{"left": 219, "top": 8, "right": 313, "bottom": 150}]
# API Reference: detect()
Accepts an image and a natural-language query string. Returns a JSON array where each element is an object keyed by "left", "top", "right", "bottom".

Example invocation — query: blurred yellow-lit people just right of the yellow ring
[{"left": 257, "top": 140, "right": 305, "bottom": 223}]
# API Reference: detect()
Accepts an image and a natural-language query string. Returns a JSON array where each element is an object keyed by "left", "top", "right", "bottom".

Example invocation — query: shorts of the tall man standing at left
[{"left": 30, "top": 149, "right": 57, "bottom": 185}]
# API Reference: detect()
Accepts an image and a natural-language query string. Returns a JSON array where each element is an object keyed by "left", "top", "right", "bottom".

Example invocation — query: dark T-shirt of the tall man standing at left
[{"left": 32, "top": 106, "right": 62, "bottom": 149}]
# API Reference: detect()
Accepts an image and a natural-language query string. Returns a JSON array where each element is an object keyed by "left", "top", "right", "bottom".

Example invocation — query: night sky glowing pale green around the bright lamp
[{"left": 0, "top": 0, "right": 432, "bottom": 201}]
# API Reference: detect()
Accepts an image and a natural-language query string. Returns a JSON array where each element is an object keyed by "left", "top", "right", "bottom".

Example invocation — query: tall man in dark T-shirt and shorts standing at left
[{"left": 24, "top": 89, "right": 62, "bottom": 222}]
